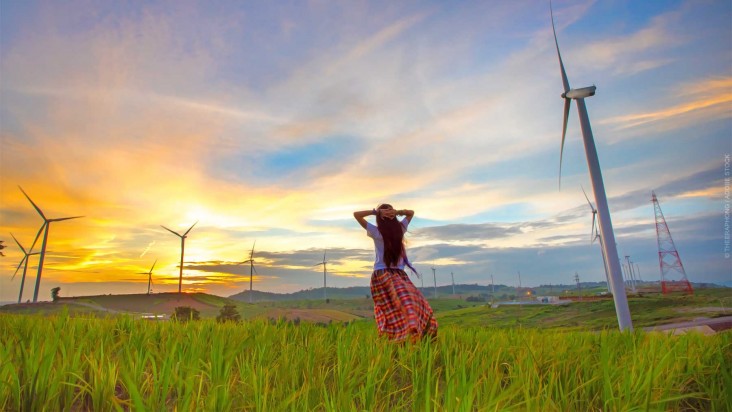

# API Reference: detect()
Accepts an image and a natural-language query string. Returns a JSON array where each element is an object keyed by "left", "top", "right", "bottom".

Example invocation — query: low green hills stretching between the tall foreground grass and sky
[{"left": 0, "top": 288, "right": 732, "bottom": 330}]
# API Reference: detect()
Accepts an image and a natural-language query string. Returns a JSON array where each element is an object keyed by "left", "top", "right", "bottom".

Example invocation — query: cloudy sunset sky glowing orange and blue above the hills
[{"left": 0, "top": 0, "right": 732, "bottom": 301}]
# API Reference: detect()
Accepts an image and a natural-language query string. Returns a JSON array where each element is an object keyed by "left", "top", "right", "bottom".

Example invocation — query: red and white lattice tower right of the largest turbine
[{"left": 651, "top": 192, "right": 694, "bottom": 294}]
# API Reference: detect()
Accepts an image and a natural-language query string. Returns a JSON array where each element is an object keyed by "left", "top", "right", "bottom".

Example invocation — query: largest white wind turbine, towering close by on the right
[{"left": 549, "top": 1, "right": 633, "bottom": 331}]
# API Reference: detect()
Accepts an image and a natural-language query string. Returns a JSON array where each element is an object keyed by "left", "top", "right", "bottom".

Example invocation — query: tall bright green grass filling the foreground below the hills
[{"left": 0, "top": 313, "right": 732, "bottom": 411}]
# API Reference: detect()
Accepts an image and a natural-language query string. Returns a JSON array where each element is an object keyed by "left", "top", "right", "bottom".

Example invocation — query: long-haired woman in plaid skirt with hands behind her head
[{"left": 353, "top": 204, "right": 437, "bottom": 342}]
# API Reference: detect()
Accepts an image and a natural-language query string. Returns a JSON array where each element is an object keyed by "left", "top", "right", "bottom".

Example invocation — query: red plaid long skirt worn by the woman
[{"left": 371, "top": 269, "right": 437, "bottom": 341}]
